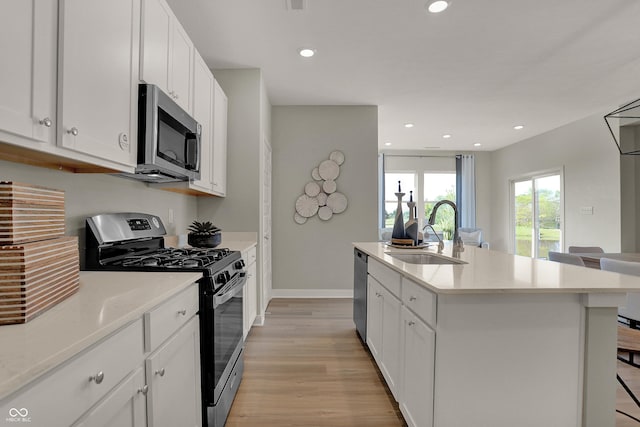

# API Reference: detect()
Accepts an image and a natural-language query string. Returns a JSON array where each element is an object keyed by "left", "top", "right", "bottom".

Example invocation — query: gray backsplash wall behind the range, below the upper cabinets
[{"left": 0, "top": 161, "right": 197, "bottom": 258}]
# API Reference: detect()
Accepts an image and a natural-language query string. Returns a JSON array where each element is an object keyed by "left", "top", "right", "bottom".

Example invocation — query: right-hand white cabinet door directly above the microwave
[{"left": 169, "top": 19, "right": 194, "bottom": 113}]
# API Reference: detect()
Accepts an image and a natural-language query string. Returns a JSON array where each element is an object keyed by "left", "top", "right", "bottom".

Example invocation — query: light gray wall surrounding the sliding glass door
[{"left": 491, "top": 112, "right": 621, "bottom": 252}]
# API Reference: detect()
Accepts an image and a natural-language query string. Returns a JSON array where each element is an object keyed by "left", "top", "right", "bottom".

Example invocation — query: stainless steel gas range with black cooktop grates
[{"left": 85, "top": 213, "right": 246, "bottom": 427}]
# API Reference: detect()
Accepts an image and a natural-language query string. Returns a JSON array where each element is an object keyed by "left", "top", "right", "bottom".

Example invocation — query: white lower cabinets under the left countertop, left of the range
[{"left": 0, "top": 284, "right": 202, "bottom": 427}]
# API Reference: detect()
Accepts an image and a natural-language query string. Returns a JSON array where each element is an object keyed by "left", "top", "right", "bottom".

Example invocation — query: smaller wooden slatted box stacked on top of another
[{"left": 0, "top": 181, "right": 65, "bottom": 245}]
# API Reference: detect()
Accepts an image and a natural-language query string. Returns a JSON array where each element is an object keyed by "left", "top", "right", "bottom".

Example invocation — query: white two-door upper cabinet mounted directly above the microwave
[{"left": 140, "top": 0, "right": 195, "bottom": 113}]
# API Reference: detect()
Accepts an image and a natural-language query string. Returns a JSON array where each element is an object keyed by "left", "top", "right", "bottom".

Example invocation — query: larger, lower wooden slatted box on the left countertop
[{"left": 0, "top": 237, "right": 80, "bottom": 325}]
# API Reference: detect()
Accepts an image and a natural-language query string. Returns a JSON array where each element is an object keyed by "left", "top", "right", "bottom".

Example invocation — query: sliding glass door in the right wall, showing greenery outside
[{"left": 511, "top": 172, "right": 564, "bottom": 258}]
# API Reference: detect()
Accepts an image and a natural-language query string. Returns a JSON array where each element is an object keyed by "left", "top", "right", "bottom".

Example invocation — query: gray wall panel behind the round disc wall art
[{"left": 272, "top": 106, "right": 378, "bottom": 297}]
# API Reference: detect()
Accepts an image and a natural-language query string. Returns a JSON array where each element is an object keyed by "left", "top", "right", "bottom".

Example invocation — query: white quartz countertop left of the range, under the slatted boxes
[{"left": 0, "top": 271, "right": 202, "bottom": 399}]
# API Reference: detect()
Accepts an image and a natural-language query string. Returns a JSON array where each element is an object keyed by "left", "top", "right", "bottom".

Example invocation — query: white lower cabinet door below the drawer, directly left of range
[{"left": 146, "top": 316, "right": 202, "bottom": 427}]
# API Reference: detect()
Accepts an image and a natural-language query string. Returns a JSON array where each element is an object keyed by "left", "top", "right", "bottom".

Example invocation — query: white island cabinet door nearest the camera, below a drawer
[{"left": 400, "top": 308, "right": 436, "bottom": 427}]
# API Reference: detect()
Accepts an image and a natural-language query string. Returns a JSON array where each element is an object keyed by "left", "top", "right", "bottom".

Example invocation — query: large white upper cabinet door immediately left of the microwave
[{"left": 58, "top": 0, "right": 140, "bottom": 166}]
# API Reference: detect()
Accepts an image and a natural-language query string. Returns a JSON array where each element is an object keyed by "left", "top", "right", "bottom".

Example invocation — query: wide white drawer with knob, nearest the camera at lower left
[{"left": 0, "top": 319, "right": 143, "bottom": 427}]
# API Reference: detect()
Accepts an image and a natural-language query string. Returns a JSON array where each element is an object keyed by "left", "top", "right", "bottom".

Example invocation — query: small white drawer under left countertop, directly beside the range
[{"left": 144, "top": 284, "right": 198, "bottom": 352}]
